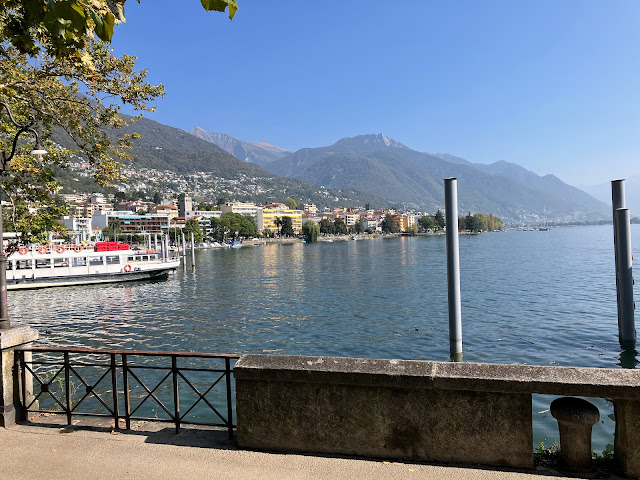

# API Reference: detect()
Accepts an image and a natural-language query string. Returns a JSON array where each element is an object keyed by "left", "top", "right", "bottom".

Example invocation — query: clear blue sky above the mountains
[{"left": 113, "top": 0, "right": 640, "bottom": 185}]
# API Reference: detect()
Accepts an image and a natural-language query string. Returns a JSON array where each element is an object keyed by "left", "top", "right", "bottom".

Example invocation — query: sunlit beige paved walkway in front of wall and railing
[{"left": 0, "top": 425, "right": 617, "bottom": 480}]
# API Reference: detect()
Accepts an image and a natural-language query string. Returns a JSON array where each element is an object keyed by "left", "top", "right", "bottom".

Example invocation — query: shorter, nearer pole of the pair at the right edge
[{"left": 614, "top": 208, "right": 636, "bottom": 348}]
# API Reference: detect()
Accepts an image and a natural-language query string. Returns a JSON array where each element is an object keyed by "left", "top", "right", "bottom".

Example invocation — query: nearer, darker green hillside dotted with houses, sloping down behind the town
[{"left": 52, "top": 118, "right": 390, "bottom": 208}]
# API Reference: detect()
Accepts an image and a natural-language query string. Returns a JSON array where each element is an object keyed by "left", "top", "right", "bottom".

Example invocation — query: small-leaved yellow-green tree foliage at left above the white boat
[{"left": 0, "top": 34, "right": 163, "bottom": 251}]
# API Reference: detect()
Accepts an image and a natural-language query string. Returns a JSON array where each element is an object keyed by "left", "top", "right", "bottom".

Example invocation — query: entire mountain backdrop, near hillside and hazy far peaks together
[{"left": 54, "top": 112, "right": 611, "bottom": 224}]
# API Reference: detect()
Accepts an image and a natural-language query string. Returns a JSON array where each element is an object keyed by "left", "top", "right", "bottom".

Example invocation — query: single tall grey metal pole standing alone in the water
[{"left": 444, "top": 178, "right": 462, "bottom": 362}]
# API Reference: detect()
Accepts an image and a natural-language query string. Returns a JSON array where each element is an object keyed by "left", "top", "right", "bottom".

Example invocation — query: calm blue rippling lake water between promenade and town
[{"left": 9, "top": 225, "right": 640, "bottom": 451}]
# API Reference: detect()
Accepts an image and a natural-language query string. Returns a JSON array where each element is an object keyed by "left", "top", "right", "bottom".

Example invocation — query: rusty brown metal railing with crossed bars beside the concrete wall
[{"left": 16, "top": 347, "right": 240, "bottom": 438}]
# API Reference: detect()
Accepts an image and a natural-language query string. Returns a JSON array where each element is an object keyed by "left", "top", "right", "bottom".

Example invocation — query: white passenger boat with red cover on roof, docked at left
[{"left": 7, "top": 242, "right": 180, "bottom": 290}]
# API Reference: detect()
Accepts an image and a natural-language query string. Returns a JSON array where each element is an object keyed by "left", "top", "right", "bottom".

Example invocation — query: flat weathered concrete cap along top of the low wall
[{"left": 234, "top": 355, "right": 640, "bottom": 399}]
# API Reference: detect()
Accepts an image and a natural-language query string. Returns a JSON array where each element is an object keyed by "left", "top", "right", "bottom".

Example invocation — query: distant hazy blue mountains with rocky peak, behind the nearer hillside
[{"left": 192, "top": 127, "right": 610, "bottom": 223}]
